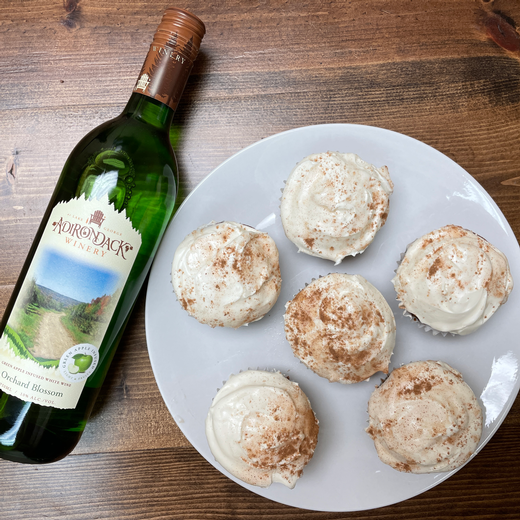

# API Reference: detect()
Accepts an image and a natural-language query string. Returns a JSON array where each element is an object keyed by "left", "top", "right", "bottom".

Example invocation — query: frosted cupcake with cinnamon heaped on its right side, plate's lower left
[{"left": 206, "top": 370, "right": 319, "bottom": 489}]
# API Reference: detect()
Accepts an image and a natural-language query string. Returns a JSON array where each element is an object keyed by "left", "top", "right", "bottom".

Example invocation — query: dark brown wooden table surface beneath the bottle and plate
[{"left": 0, "top": 0, "right": 520, "bottom": 520}]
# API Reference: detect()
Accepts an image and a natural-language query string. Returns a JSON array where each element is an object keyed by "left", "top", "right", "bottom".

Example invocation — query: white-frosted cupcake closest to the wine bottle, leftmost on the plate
[{"left": 172, "top": 222, "right": 282, "bottom": 329}]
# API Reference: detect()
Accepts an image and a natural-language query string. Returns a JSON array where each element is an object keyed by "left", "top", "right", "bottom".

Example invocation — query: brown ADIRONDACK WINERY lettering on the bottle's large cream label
[{"left": 52, "top": 213, "right": 134, "bottom": 260}]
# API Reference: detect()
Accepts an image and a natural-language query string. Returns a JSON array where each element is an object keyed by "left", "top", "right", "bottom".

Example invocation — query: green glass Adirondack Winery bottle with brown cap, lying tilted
[{"left": 0, "top": 8, "right": 205, "bottom": 463}]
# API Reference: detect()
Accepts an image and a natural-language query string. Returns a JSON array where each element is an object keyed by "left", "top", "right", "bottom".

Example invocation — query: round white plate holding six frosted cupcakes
[{"left": 146, "top": 124, "right": 520, "bottom": 511}]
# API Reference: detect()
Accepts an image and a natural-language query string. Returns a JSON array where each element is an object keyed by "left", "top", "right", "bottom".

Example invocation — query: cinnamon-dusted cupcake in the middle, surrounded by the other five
[{"left": 285, "top": 273, "right": 395, "bottom": 384}]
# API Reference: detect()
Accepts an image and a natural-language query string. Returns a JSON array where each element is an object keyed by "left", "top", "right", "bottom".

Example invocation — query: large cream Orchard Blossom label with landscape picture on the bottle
[{"left": 0, "top": 196, "right": 141, "bottom": 409}]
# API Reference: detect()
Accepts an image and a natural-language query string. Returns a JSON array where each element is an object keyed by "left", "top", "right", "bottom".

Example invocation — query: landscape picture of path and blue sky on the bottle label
[{"left": 5, "top": 248, "right": 121, "bottom": 366}]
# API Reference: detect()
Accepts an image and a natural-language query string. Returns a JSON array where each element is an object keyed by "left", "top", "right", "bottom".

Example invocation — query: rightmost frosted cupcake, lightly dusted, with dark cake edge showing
[{"left": 392, "top": 225, "right": 513, "bottom": 335}]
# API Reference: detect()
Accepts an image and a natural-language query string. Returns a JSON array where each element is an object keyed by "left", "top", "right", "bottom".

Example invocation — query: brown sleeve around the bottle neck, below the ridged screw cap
[{"left": 134, "top": 40, "right": 193, "bottom": 110}]
